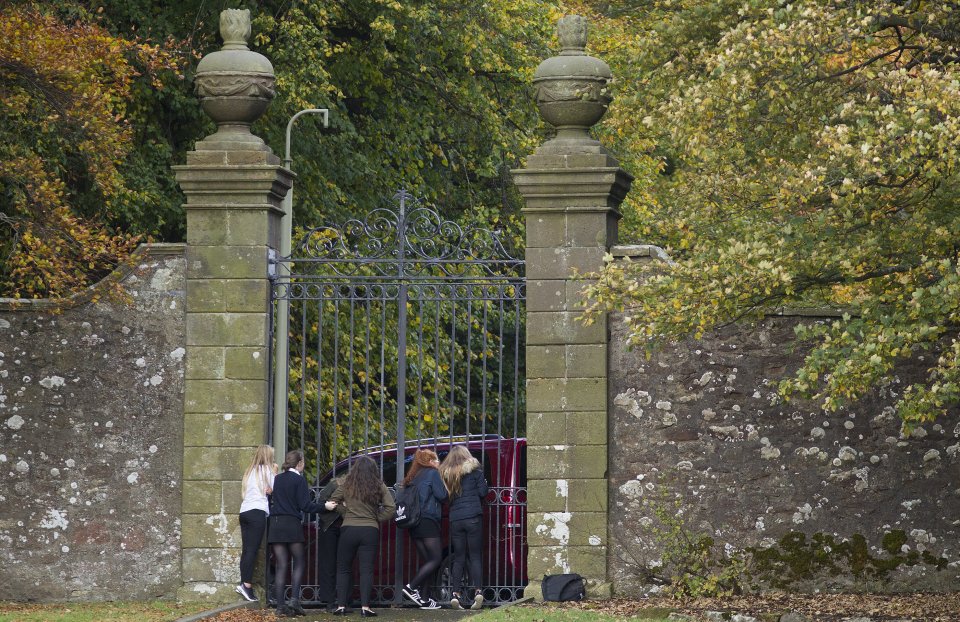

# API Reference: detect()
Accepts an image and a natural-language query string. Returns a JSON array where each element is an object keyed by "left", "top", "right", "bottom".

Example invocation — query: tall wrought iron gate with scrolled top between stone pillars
[{"left": 271, "top": 191, "right": 526, "bottom": 605}]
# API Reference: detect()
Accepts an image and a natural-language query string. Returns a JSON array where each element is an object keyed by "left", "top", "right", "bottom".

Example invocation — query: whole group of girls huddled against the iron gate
[{"left": 236, "top": 445, "right": 488, "bottom": 617}]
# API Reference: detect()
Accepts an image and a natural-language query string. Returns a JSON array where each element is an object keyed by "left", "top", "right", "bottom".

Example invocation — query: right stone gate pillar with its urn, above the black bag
[{"left": 513, "top": 15, "right": 633, "bottom": 598}]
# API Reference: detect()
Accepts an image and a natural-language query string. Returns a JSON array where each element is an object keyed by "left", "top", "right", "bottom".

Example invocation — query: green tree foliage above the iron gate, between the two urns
[{"left": 254, "top": 0, "right": 550, "bottom": 227}]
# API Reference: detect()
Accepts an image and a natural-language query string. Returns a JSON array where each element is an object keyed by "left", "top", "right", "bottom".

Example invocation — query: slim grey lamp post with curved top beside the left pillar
[{"left": 273, "top": 108, "right": 330, "bottom": 460}]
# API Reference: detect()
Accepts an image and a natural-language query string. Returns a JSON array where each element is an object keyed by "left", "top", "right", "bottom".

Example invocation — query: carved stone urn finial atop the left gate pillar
[{"left": 194, "top": 9, "right": 276, "bottom": 149}]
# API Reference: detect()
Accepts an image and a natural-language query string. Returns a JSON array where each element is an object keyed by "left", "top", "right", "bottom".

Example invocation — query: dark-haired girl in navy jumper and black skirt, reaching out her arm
[{"left": 267, "top": 449, "right": 323, "bottom": 616}]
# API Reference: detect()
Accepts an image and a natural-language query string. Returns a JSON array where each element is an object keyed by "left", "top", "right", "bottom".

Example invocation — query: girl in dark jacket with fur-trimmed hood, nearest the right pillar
[{"left": 440, "top": 445, "right": 488, "bottom": 609}]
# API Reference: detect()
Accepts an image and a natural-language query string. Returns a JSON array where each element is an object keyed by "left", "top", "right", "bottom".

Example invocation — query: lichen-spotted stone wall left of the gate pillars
[{"left": 0, "top": 245, "right": 185, "bottom": 601}]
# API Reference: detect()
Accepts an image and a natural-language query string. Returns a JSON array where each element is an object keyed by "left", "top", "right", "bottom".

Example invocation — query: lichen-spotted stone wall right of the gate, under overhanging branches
[{"left": 608, "top": 317, "right": 960, "bottom": 595}]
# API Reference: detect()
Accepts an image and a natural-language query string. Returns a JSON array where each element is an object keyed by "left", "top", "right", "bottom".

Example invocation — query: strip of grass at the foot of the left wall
[{"left": 0, "top": 601, "right": 210, "bottom": 622}]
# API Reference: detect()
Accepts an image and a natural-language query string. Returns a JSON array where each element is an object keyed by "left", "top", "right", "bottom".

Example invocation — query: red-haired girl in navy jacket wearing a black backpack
[{"left": 402, "top": 449, "right": 447, "bottom": 609}]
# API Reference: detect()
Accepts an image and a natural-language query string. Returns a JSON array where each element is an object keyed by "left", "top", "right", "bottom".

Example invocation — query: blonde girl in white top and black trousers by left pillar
[{"left": 236, "top": 445, "right": 278, "bottom": 601}]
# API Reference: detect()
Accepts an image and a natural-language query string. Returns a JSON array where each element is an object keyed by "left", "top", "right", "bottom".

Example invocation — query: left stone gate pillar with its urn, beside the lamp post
[{"left": 174, "top": 9, "right": 292, "bottom": 600}]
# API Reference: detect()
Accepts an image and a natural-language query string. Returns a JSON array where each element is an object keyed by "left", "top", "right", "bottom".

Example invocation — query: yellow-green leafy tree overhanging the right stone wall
[{"left": 588, "top": 0, "right": 960, "bottom": 425}]
